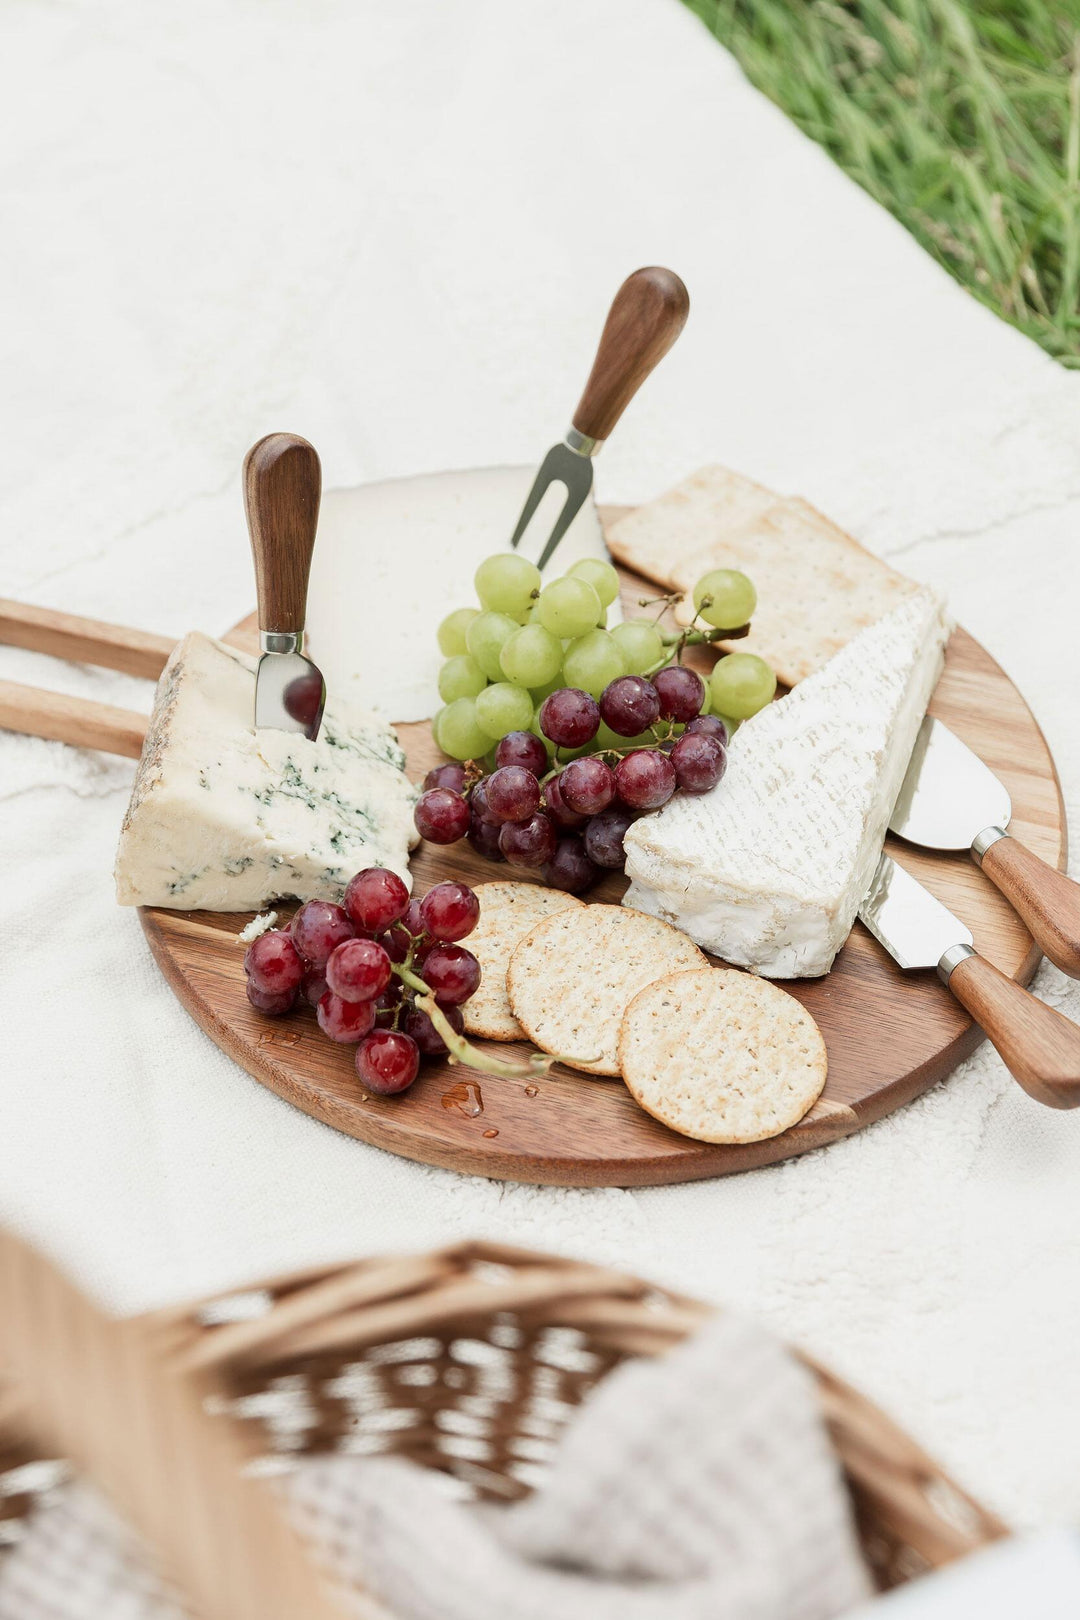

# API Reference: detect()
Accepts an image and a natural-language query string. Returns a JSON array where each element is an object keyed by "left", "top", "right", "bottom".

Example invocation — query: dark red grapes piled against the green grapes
[{"left": 416, "top": 664, "right": 727, "bottom": 894}]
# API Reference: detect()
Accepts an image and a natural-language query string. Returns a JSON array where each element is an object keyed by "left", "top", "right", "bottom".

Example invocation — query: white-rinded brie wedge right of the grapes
[{"left": 623, "top": 590, "right": 949, "bottom": 978}]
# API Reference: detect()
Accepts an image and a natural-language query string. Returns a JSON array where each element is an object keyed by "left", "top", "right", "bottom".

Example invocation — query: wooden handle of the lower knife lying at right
[{"left": 949, "top": 956, "right": 1080, "bottom": 1108}]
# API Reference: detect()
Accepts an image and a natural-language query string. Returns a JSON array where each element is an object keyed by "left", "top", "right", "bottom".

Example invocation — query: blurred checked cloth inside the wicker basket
[{"left": 0, "top": 1314, "right": 871, "bottom": 1620}]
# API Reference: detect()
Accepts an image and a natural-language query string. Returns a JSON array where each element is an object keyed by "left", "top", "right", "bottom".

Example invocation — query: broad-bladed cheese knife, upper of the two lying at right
[{"left": 889, "top": 714, "right": 1080, "bottom": 978}]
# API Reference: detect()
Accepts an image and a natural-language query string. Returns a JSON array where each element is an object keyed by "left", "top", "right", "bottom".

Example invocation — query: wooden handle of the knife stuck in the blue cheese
[{"left": 244, "top": 433, "right": 322, "bottom": 633}]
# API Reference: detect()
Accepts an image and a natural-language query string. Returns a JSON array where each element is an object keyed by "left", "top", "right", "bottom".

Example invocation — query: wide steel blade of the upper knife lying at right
[{"left": 889, "top": 714, "right": 1012, "bottom": 849}]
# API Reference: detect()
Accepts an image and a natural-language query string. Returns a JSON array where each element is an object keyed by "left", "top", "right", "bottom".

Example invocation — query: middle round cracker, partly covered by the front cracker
[{"left": 507, "top": 906, "right": 708, "bottom": 1074}]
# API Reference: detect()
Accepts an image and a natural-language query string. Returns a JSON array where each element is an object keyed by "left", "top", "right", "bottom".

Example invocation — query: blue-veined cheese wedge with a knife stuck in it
[{"left": 117, "top": 633, "right": 418, "bottom": 912}]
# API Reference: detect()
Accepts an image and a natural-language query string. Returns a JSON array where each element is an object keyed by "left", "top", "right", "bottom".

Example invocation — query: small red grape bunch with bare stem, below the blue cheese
[{"left": 244, "top": 867, "right": 554, "bottom": 1097}]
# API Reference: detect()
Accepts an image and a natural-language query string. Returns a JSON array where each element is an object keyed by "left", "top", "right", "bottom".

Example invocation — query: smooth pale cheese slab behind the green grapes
[{"left": 308, "top": 467, "right": 617, "bottom": 721}]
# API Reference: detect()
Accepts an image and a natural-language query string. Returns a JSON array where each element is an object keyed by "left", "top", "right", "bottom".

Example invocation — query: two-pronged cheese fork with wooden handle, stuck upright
[{"left": 510, "top": 266, "right": 690, "bottom": 572}]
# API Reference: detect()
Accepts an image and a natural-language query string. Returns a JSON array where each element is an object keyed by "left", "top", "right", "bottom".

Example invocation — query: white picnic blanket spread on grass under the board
[{"left": 0, "top": 0, "right": 1080, "bottom": 1523}]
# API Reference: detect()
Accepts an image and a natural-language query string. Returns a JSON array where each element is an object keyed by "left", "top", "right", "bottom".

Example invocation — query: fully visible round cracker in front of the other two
[{"left": 619, "top": 967, "right": 827, "bottom": 1142}]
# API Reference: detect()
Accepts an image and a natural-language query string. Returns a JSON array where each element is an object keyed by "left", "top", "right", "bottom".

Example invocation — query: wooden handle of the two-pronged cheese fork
[{"left": 573, "top": 266, "right": 690, "bottom": 439}]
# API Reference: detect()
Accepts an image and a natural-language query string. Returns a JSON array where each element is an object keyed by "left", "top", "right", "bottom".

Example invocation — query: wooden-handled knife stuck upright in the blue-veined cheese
[{"left": 244, "top": 433, "right": 325, "bottom": 742}]
